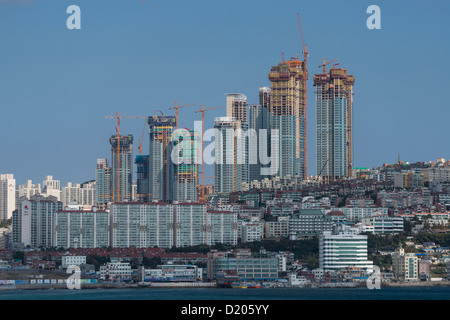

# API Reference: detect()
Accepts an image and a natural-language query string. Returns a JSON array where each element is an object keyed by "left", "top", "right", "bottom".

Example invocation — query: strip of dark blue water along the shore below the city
[{"left": 0, "top": 287, "right": 450, "bottom": 301}]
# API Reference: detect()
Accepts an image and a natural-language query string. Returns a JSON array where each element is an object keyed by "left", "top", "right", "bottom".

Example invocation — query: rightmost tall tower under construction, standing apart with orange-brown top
[{"left": 314, "top": 67, "right": 355, "bottom": 182}]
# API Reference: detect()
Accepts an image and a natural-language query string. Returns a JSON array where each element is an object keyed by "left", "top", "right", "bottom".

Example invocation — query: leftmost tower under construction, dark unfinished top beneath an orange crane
[{"left": 109, "top": 135, "right": 133, "bottom": 202}]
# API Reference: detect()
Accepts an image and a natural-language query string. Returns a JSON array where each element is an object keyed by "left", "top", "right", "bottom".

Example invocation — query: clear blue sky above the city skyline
[{"left": 0, "top": 0, "right": 450, "bottom": 184}]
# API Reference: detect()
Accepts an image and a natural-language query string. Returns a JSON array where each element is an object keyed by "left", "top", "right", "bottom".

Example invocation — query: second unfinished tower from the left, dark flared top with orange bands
[{"left": 148, "top": 116, "right": 177, "bottom": 201}]
